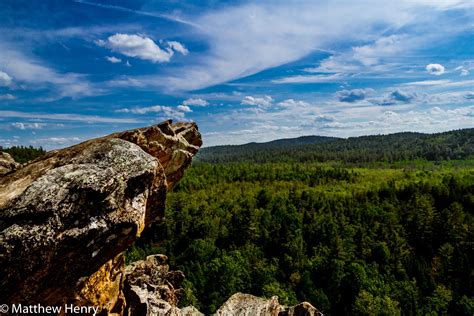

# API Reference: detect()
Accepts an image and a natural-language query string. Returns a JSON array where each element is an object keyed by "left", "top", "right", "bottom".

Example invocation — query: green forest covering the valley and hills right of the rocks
[{"left": 127, "top": 129, "right": 474, "bottom": 315}]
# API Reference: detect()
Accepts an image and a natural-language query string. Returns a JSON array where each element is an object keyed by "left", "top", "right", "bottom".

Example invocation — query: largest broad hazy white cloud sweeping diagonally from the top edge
[{"left": 121, "top": 1, "right": 413, "bottom": 90}]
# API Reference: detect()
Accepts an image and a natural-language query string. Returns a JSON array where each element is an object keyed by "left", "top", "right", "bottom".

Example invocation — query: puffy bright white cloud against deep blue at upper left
[{"left": 96, "top": 33, "right": 188, "bottom": 63}]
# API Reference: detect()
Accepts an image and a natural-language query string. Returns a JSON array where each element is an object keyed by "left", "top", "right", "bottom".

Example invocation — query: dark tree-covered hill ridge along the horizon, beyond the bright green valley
[{"left": 197, "top": 128, "right": 474, "bottom": 163}]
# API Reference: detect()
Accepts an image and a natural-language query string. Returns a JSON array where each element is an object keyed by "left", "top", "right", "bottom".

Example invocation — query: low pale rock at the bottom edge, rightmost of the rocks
[{"left": 215, "top": 293, "right": 323, "bottom": 316}]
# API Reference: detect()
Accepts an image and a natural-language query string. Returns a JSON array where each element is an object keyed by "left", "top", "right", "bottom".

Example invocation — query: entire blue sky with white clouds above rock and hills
[{"left": 0, "top": 0, "right": 474, "bottom": 149}]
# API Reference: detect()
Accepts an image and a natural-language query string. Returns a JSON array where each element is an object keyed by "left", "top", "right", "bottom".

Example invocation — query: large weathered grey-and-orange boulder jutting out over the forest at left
[{"left": 0, "top": 121, "right": 202, "bottom": 311}]
